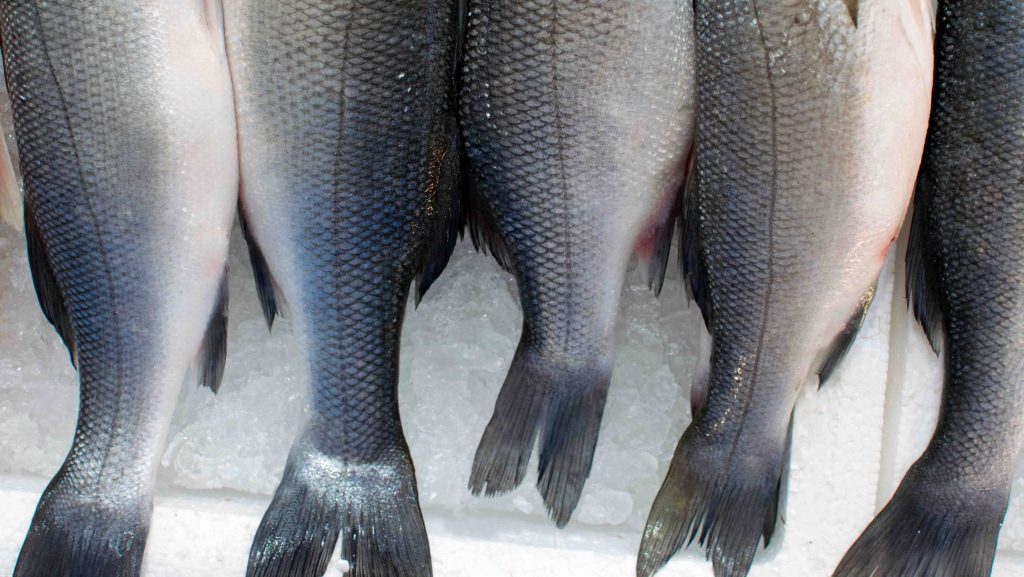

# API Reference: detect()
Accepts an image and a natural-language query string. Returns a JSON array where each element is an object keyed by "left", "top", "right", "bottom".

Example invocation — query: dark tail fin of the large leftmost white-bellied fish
[{"left": 14, "top": 472, "right": 153, "bottom": 577}]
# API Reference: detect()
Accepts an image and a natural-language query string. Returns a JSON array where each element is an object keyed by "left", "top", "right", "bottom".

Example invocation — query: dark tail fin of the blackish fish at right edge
[{"left": 833, "top": 469, "right": 1009, "bottom": 577}]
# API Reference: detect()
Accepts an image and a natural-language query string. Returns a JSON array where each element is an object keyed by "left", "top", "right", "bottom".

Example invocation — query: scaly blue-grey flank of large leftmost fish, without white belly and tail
[{"left": 0, "top": 1, "right": 166, "bottom": 496}]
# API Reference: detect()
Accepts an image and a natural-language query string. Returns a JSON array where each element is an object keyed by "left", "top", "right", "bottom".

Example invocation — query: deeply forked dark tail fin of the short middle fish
[{"left": 469, "top": 345, "right": 610, "bottom": 527}]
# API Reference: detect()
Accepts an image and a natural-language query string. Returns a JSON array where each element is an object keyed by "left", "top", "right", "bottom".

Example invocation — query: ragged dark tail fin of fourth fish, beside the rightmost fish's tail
[{"left": 637, "top": 424, "right": 792, "bottom": 577}]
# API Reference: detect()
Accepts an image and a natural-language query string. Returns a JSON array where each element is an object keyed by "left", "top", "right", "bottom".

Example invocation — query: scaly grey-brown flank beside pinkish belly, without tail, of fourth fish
[{"left": 695, "top": 0, "right": 859, "bottom": 445}]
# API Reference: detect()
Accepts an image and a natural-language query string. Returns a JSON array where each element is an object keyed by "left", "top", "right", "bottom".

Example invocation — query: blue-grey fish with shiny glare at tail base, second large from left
[{"left": 224, "top": 0, "right": 462, "bottom": 577}]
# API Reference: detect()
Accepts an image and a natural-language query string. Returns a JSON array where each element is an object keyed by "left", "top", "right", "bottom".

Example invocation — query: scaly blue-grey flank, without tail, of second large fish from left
[{"left": 230, "top": 1, "right": 452, "bottom": 459}]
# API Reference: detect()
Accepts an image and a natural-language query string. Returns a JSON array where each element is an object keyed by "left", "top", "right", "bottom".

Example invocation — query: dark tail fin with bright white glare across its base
[{"left": 246, "top": 450, "right": 432, "bottom": 577}]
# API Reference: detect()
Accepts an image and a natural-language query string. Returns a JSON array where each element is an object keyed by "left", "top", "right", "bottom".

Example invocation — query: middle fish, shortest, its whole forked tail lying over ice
[{"left": 460, "top": 0, "right": 696, "bottom": 527}]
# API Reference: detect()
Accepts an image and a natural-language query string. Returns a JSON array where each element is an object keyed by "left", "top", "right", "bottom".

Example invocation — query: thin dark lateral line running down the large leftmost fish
[{"left": 33, "top": 2, "right": 125, "bottom": 489}]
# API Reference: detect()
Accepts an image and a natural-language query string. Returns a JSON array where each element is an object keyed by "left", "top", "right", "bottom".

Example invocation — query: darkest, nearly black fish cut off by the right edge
[{"left": 834, "top": 0, "right": 1024, "bottom": 577}]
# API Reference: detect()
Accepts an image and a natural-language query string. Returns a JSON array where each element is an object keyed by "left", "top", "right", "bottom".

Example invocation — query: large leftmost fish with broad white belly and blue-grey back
[{"left": 0, "top": 0, "right": 238, "bottom": 577}]
